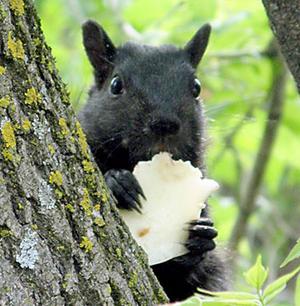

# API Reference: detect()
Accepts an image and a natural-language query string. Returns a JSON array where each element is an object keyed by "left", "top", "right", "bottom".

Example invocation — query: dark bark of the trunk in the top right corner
[{"left": 262, "top": 0, "right": 300, "bottom": 92}]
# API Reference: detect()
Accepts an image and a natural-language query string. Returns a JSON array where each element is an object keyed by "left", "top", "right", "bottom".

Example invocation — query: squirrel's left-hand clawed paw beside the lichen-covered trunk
[{"left": 104, "top": 169, "right": 145, "bottom": 213}]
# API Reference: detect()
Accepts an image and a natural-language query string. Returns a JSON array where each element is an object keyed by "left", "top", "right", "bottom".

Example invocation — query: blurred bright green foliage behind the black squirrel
[{"left": 35, "top": 0, "right": 300, "bottom": 305}]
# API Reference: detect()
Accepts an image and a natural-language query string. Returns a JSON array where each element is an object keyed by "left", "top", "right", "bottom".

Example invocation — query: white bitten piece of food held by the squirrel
[{"left": 120, "top": 152, "right": 218, "bottom": 265}]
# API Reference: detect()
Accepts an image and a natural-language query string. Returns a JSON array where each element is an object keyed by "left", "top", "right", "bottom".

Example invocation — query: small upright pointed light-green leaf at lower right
[{"left": 244, "top": 255, "right": 269, "bottom": 290}]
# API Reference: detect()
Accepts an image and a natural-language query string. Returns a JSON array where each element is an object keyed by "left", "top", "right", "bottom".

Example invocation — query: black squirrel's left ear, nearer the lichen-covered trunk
[{"left": 82, "top": 20, "right": 116, "bottom": 83}]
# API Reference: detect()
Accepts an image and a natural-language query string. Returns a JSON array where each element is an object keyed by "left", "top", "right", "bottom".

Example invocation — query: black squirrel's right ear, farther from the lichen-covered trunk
[{"left": 184, "top": 23, "right": 211, "bottom": 68}]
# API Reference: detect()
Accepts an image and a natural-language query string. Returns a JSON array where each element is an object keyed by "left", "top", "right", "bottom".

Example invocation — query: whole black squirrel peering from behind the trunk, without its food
[{"left": 79, "top": 21, "right": 227, "bottom": 301}]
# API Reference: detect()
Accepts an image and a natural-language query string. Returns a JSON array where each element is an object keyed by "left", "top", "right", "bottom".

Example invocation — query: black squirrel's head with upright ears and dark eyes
[{"left": 82, "top": 21, "right": 211, "bottom": 169}]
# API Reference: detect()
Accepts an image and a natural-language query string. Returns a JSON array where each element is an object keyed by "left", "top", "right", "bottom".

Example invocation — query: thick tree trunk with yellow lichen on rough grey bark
[{"left": 0, "top": 0, "right": 165, "bottom": 306}]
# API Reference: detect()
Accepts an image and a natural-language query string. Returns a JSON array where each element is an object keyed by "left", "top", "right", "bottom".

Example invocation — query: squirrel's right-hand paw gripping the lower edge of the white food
[{"left": 185, "top": 218, "right": 218, "bottom": 255}]
